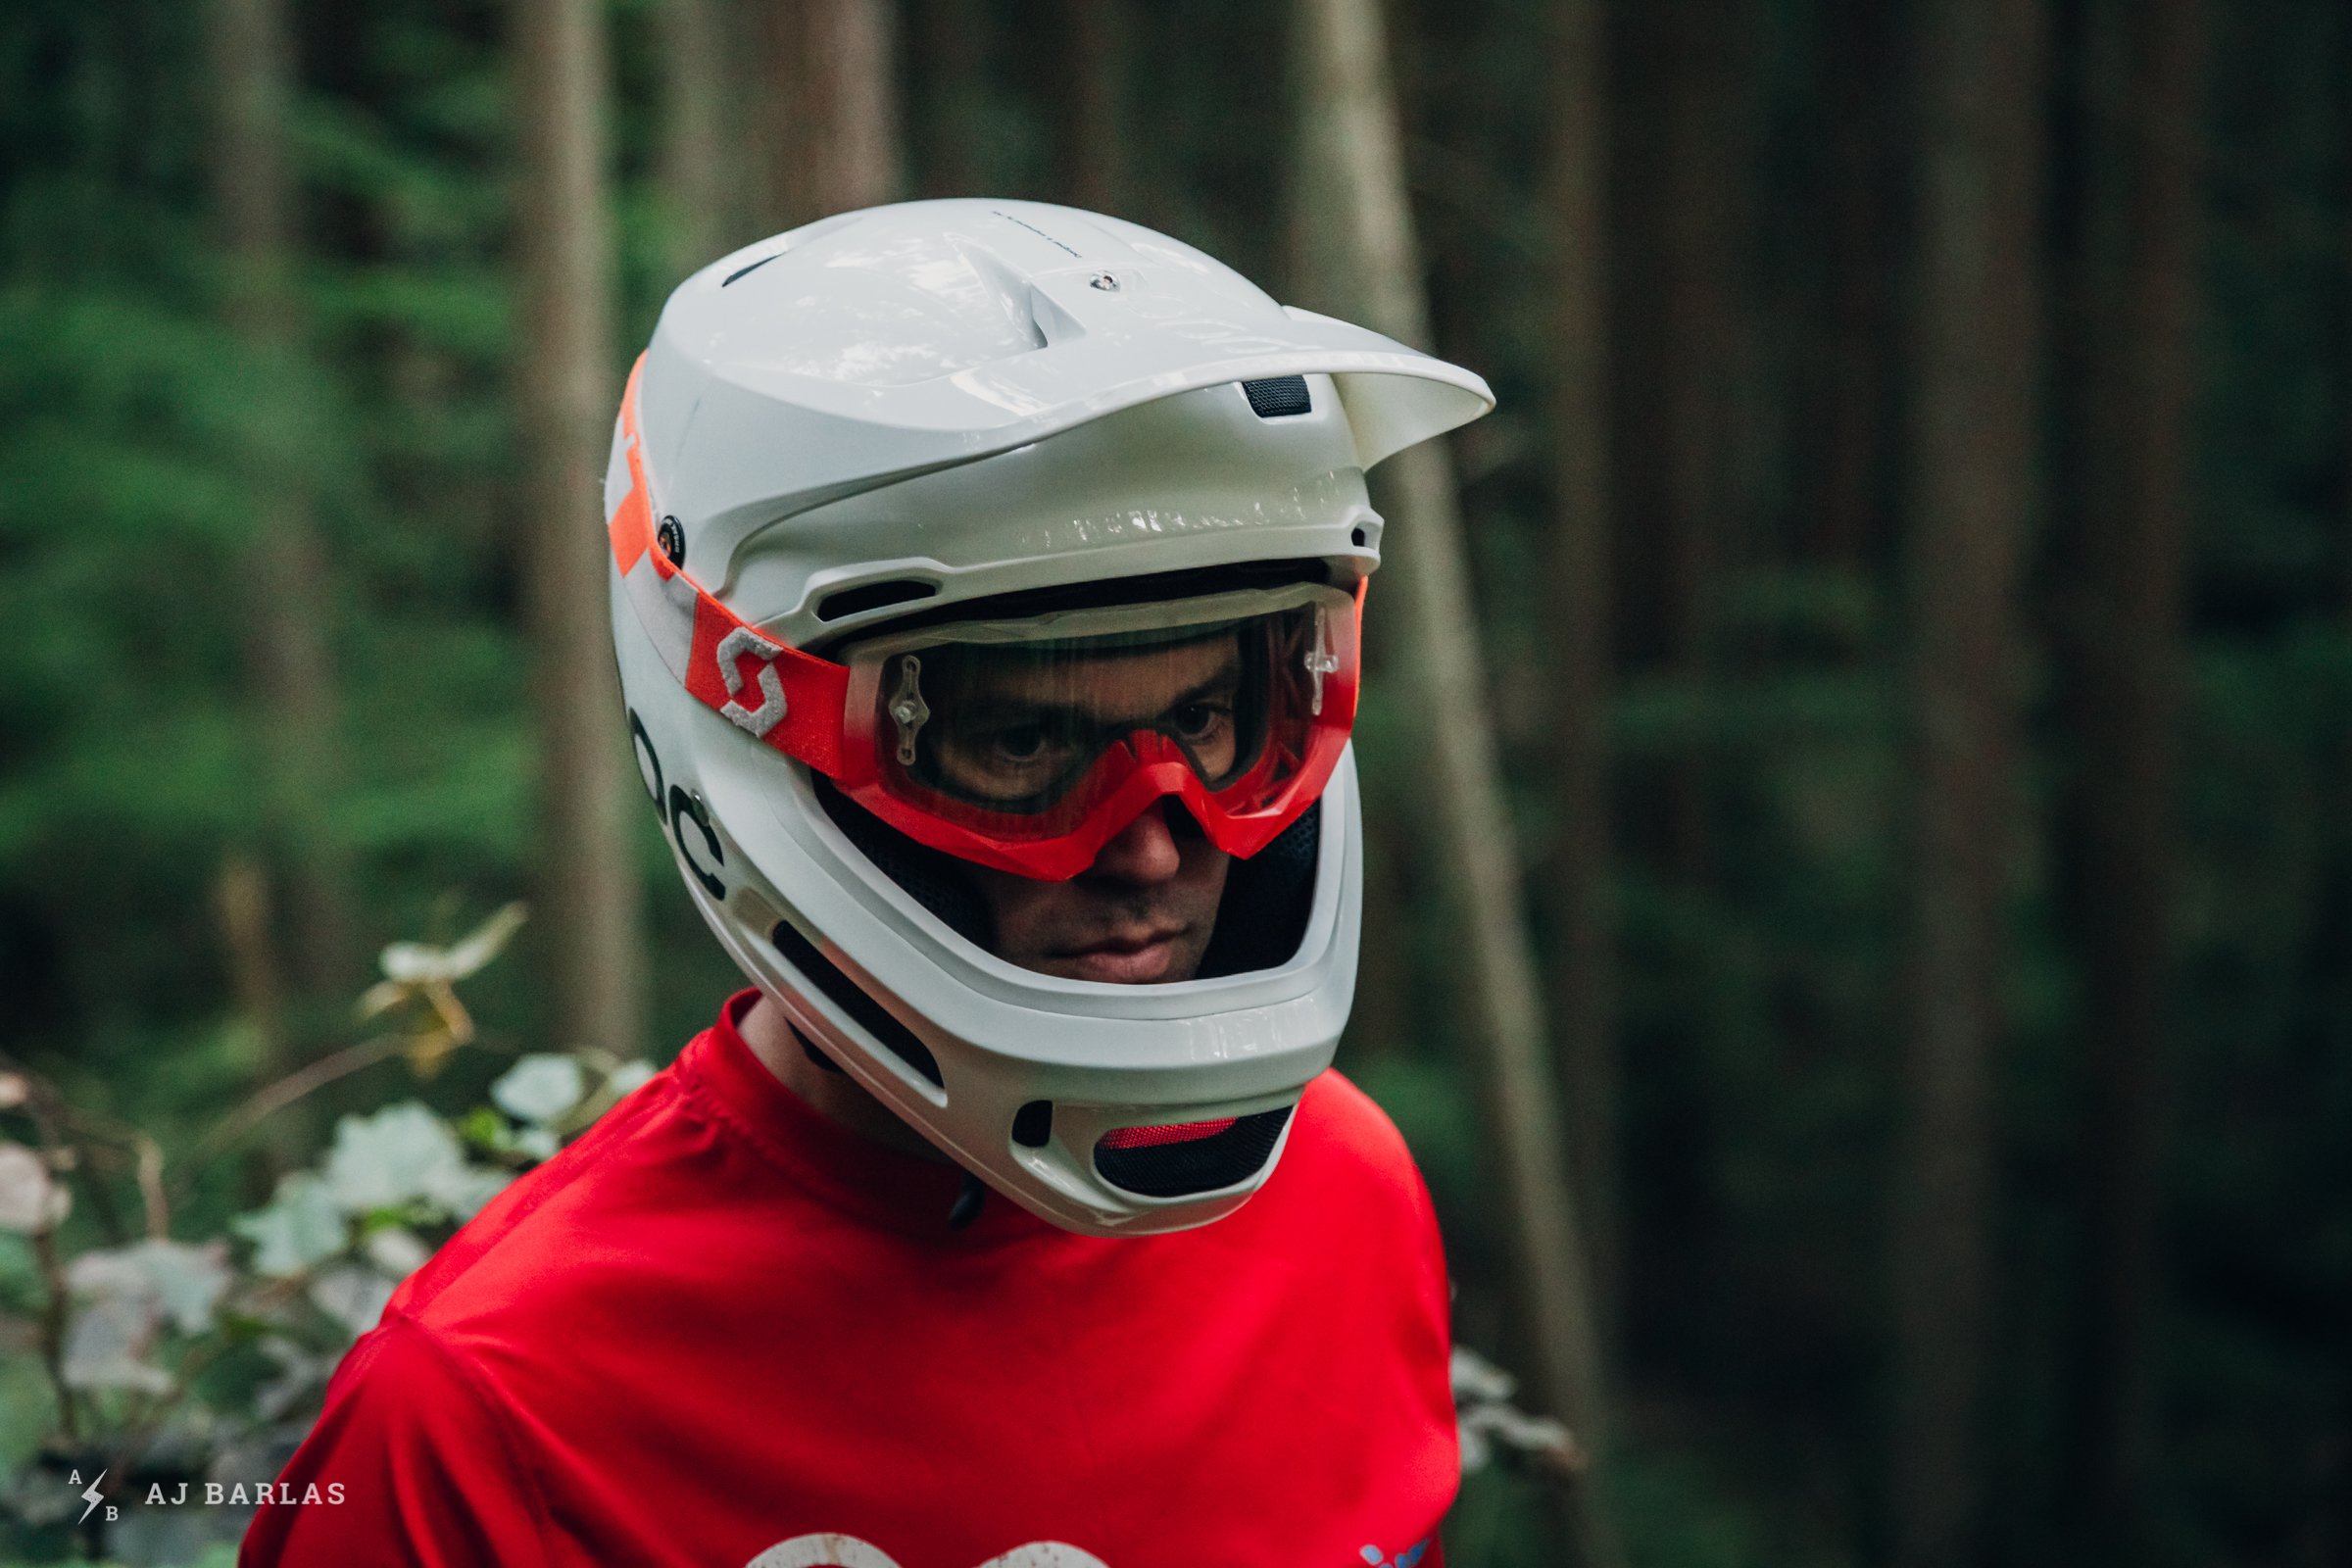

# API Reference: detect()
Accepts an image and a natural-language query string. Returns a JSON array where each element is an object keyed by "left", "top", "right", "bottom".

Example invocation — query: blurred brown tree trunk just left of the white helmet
[{"left": 515, "top": 0, "right": 645, "bottom": 1057}]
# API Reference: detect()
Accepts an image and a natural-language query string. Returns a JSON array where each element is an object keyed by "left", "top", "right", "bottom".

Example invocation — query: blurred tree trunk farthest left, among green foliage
[{"left": 210, "top": 0, "right": 365, "bottom": 1010}]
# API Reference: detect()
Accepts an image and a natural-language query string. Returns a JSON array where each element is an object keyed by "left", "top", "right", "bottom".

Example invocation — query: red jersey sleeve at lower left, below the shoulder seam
[{"left": 237, "top": 1316, "right": 548, "bottom": 1568}]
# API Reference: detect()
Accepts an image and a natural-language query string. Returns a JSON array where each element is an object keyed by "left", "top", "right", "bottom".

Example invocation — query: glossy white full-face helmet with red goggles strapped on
[{"left": 605, "top": 200, "right": 1494, "bottom": 1237}]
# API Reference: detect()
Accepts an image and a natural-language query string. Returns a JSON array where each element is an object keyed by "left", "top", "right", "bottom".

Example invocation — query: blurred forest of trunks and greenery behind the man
[{"left": 0, "top": 0, "right": 2352, "bottom": 1568}]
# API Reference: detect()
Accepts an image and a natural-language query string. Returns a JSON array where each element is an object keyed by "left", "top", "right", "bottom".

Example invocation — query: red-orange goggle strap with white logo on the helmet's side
[{"left": 605, "top": 367, "right": 849, "bottom": 778}]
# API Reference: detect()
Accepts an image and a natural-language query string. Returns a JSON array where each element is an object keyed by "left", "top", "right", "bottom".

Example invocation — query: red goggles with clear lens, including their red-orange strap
[{"left": 610, "top": 362, "right": 1362, "bottom": 882}]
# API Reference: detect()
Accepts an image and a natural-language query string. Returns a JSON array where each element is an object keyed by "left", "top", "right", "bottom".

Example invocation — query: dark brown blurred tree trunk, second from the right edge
[{"left": 1888, "top": 0, "right": 2044, "bottom": 1568}]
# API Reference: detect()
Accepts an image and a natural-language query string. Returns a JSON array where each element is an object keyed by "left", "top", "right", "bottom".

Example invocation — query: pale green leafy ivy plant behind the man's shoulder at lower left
[{"left": 0, "top": 926, "right": 652, "bottom": 1563}]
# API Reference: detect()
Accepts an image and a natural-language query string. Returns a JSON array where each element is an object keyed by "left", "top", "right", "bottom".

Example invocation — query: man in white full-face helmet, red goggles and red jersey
[{"left": 242, "top": 200, "right": 1492, "bottom": 1568}]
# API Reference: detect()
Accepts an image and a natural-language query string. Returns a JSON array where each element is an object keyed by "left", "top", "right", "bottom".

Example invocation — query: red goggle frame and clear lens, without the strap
[{"left": 845, "top": 583, "right": 1357, "bottom": 877}]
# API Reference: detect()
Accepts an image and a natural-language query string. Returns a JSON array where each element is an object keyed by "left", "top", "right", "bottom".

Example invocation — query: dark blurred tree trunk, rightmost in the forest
[{"left": 2068, "top": 0, "right": 2204, "bottom": 1561}]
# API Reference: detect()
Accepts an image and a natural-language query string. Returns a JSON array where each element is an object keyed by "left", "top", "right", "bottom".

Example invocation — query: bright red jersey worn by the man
[{"left": 237, "top": 992, "right": 1458, "bottom": 1568}]
